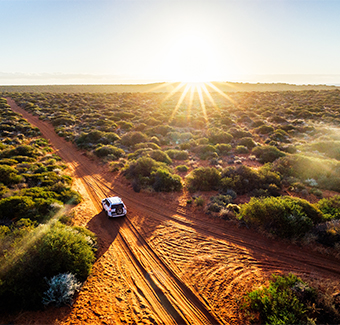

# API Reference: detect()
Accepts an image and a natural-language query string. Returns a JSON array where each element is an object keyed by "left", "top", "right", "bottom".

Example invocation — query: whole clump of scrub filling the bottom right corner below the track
[{"left": 245, "top": 274, "right": 340, "bottom": 324}]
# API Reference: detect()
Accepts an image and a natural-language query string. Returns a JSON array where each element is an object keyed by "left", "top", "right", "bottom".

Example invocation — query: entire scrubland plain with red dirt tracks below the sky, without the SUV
[{"left": 0, "top": 83, "right": 340, "bottom": 324}]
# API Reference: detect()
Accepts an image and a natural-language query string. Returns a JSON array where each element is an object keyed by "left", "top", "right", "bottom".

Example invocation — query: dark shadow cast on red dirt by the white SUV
[{"left": 87, "top": 211, "right": 125, "bottom": 258}]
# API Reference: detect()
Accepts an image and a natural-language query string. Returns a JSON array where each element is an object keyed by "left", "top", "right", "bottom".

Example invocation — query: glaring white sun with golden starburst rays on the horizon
[{"left": 150, "top": 28, "right": 233, "bottom": 124}]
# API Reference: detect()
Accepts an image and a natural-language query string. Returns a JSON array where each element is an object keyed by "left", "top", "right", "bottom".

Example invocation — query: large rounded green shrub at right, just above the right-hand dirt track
[{"left": 240, "top": 197, "right": 324, "bottom": 238}]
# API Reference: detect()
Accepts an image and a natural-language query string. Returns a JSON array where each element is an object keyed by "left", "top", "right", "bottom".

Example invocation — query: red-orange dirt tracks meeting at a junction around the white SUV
[{"left": 8, "top": 99, "right": 340, "bottom": 325}]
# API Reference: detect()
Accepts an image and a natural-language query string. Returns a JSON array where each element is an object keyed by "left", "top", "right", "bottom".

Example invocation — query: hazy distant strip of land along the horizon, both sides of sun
[{"left": 0, "top": 82, "right": 340, "bottom": 93}]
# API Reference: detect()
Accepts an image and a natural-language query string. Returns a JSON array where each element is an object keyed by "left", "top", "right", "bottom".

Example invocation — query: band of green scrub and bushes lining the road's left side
[{"left": 0, "top": 99, "right": 96, "bottom": 312}]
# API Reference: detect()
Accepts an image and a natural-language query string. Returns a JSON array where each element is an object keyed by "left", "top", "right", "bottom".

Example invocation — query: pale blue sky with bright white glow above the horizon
[{"left": 0, "top": 0, "right": 340, "bottom": 85}]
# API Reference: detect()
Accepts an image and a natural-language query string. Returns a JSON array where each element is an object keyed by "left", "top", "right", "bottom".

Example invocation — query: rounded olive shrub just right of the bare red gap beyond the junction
[{"left": 186, "top": 167, "right": 221, "bottom": 192}]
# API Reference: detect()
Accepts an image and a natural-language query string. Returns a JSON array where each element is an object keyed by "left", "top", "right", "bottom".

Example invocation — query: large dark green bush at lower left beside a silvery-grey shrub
[{"left": 0, "top": 222, "right": 95, "bottom": 311}]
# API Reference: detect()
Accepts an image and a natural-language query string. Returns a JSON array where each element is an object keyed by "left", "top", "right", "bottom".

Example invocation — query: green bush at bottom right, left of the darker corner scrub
[{"left": 248, "top": 274, "right": 316, "bottom": 324}]
